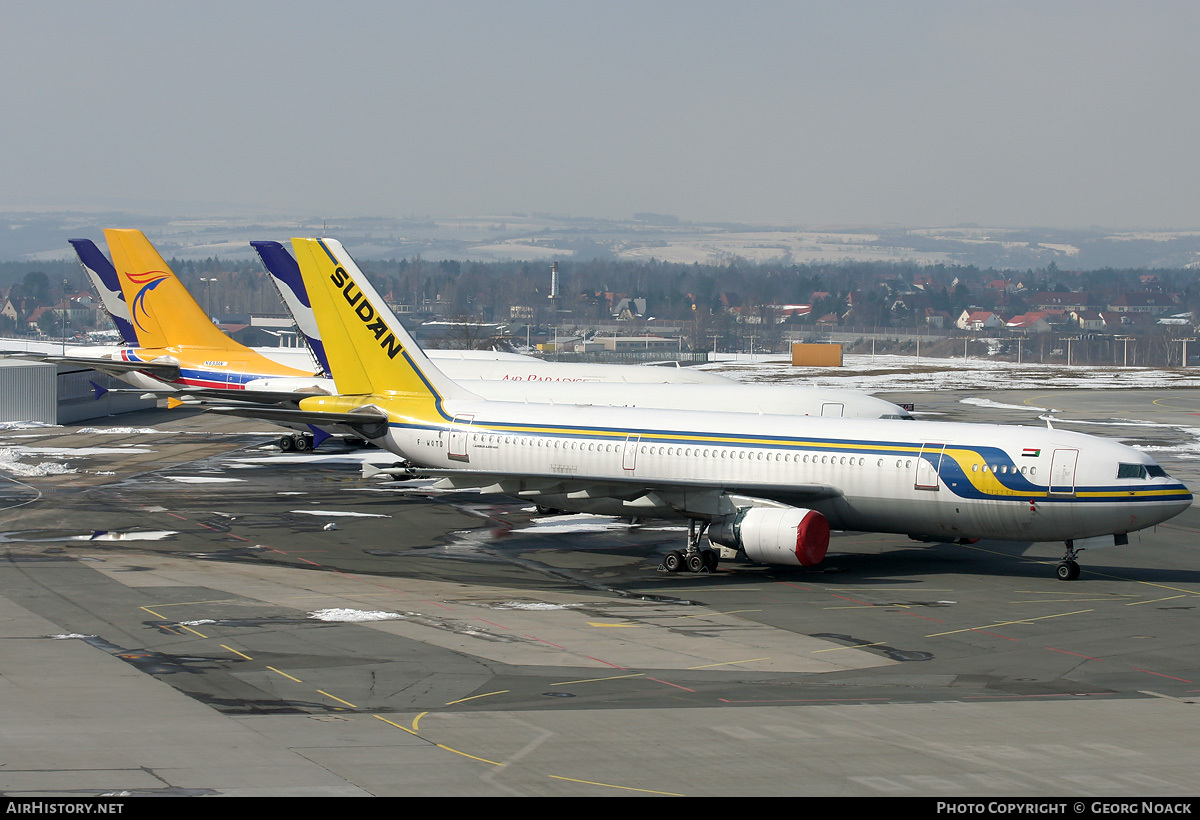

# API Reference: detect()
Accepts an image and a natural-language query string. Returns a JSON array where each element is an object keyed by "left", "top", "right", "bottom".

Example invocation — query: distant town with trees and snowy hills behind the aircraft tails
[{"left": 0, "top": 214, "right": 1200, "bottom": 366}]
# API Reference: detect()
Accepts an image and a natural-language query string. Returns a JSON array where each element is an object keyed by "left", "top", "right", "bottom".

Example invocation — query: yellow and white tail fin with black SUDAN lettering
[{"left": 292, "top": 239, "right": 478, "bottom": 408}]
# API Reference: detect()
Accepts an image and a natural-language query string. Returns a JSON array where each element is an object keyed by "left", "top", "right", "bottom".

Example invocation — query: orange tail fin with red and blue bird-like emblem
[{"left": 104, "top": 229, "right": 241, "bottom": 351}]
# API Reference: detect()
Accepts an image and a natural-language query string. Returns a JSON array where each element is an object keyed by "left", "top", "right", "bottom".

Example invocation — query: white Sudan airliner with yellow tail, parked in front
[{"left": 211, "top": 238, "right": 1192, "bottom": 580}]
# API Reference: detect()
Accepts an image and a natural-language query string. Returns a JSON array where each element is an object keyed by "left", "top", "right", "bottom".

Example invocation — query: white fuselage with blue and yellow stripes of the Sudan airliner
[{"left": 355, "top": 400, "right": 1192, "bottom": 541}]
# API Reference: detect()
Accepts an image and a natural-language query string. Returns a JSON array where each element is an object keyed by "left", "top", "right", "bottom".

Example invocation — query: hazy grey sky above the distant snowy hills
[{"left": 0, "top": 0, "right": 1200, "bottom": 228}]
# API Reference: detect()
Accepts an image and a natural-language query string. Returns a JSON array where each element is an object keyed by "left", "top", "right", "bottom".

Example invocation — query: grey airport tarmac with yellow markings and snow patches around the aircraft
[{"left": 0, "top": 389, "right": 1200, "bottom": 798}]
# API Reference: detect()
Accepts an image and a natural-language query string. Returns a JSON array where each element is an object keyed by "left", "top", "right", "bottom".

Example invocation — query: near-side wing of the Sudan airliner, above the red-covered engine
[{"left": 362, "top": 465, "right": 842, "bottom": 517}]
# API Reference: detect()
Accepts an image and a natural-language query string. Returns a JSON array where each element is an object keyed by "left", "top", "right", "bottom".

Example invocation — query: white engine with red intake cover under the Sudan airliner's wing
[{"left": 708, "top": 507, "right": 829, "bottom": 567}]
